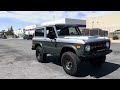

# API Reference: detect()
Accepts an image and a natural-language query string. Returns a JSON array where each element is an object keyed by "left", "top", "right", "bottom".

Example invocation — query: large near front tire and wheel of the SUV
[{"left": 61, "top": 52, "right": 80, "bottom": 76}]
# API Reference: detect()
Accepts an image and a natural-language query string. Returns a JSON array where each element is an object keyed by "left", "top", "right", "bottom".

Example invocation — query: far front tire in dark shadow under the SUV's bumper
[{"left": 90, "top": 56, "right": 106, "bottom": 67}]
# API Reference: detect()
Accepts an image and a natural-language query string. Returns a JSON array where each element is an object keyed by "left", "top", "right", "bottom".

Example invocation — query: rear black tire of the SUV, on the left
[{"left": 36, "top": 46, "right": 47, "bottom": 63}]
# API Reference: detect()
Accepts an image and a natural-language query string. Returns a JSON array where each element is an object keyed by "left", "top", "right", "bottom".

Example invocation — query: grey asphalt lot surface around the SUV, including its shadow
[{"left": 0, "top": 39, "right": 120, "bottom": 79}]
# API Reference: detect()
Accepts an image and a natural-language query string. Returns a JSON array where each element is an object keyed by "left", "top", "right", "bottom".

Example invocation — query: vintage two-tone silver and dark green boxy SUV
[{"left": 32, "top": 24, "right": 112, "bottom": 75}]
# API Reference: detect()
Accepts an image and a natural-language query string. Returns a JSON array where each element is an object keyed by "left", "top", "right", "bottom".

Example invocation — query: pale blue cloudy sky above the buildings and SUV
[{"left": 0, "top": 11, "right": 120, "bottom": 31}]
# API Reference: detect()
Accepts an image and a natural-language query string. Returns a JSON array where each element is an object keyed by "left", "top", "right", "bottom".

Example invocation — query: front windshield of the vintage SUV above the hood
[{"left": 56, "top": 26, "right": 81, "bottom": 36}]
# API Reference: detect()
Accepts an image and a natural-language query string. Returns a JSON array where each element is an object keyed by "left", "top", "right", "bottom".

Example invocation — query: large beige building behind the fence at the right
[{"left": 86, "top": 13, "right": 120, "bottom": 32}]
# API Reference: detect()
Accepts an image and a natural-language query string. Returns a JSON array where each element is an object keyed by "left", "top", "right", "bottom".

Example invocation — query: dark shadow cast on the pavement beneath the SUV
[{"left": 47, "top": 56, "right": 120, "bottom": 78}]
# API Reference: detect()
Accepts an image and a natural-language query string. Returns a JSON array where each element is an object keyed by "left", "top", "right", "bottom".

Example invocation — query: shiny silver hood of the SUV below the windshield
[{"left": 64, "top": 36, "right": 108, "bottom": 42}]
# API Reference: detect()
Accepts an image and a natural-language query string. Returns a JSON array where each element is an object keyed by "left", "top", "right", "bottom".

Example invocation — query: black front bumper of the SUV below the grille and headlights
[{"left": 81, "top": 50, "right": 112, "bottom": 59}]
